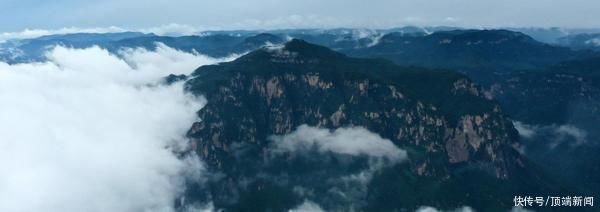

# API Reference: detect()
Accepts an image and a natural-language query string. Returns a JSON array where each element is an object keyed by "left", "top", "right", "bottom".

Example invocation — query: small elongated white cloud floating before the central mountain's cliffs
[{"left": 270, "top": 125, "right": 406, "bottom": 161}]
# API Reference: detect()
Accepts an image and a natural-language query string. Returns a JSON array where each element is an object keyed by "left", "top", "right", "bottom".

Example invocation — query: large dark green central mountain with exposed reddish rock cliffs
[{"left": 182, "top": 40, "right": 564, "bottom": 210}]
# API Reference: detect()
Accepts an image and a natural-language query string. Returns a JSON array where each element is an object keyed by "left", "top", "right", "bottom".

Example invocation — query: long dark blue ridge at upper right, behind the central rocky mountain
[{"left": 342, "top": 30, "right": 596, "bottom": 84}]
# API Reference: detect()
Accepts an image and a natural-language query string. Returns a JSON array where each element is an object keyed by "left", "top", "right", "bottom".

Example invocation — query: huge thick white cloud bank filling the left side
[{"left": 0, "top": 45, "right": 229, "bottom": 212}]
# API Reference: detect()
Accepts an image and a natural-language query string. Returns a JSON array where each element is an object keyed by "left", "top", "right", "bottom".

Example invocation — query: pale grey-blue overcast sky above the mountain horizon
[{"left": 0, "top": 0, "right": 600, "bottom": 32}]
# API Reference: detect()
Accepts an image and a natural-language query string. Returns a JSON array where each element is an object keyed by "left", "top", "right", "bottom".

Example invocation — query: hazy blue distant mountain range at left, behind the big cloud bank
[{"left": 0, "top": 32, "right": 285, "bottom": 63}]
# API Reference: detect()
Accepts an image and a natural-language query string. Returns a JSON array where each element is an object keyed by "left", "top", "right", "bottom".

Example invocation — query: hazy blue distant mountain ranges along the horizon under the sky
[{"left": 0, "top": 27, "right": 600, "bottom": 63}]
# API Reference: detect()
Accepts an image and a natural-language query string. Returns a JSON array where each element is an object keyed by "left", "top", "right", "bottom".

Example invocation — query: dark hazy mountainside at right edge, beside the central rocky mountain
[{"left": 490, "top": 58, "right": 600, "bottom": 194}]
